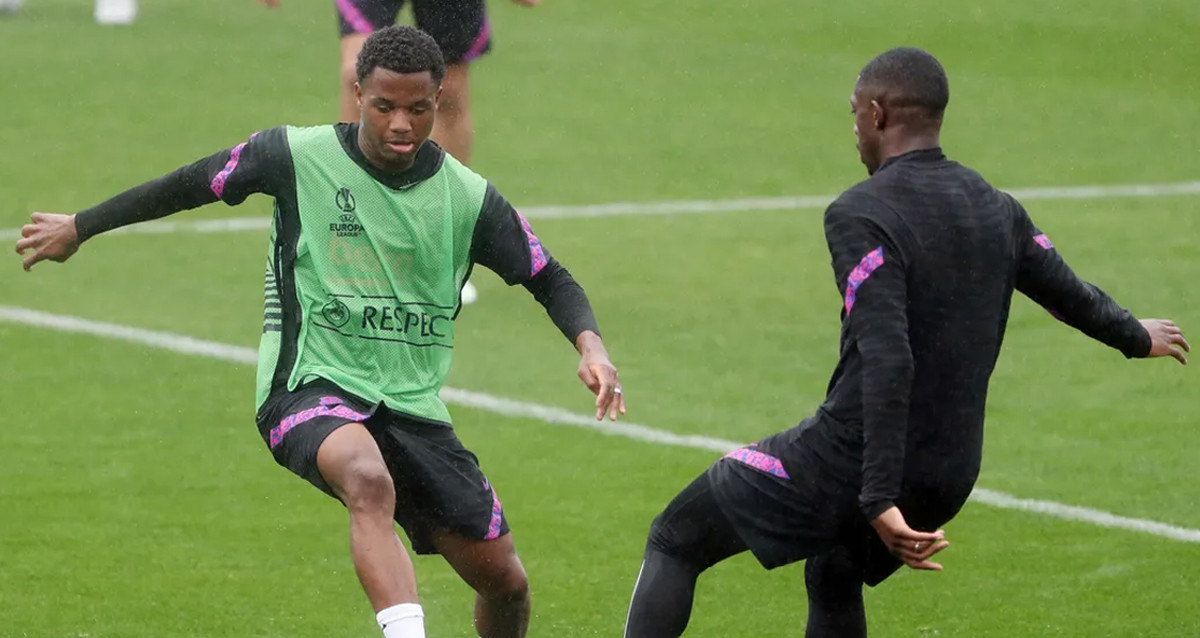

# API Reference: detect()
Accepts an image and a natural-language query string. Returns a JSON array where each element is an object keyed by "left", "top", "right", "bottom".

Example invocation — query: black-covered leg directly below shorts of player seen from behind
[{"left": 804, "top": 548, "right": 866, "bottom": 638}]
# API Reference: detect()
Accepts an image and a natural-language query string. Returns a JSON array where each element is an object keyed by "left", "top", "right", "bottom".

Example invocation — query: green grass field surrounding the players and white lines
[{"left": 0, "top": 0, "right": 1200, "bottom": 638}]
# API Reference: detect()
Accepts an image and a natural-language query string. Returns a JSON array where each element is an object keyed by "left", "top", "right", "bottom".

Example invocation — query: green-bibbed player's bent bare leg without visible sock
[{"left": 434, "top": 531, "right": 530, "bottom": 638}]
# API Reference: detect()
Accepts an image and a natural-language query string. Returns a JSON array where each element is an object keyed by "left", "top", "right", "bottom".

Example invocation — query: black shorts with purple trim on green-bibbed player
[{"left": 257, "top": 380, "right": 509, "bottom": 554}]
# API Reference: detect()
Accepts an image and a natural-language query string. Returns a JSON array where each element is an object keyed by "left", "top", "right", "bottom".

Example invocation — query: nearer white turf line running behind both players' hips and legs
[{"left": 0, "top": 306, "right": 1200, "bottom": 543}]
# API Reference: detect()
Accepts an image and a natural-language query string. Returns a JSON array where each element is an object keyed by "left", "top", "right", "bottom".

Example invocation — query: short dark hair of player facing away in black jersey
[{"left": 858, "top": 47, "right": 950, "bottom": 120}]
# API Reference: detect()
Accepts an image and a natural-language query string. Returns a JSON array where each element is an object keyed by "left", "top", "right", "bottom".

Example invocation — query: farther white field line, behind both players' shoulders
[{"left": 0, "top": 181, "right": 1200, "bottom": 241}]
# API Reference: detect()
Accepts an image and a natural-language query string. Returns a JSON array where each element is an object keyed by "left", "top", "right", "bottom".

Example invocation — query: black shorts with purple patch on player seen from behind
[{"left": 708, "top": 419, "right": 966, "bottom": 585}]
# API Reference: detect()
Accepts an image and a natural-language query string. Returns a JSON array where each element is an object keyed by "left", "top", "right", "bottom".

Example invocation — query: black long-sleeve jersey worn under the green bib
[{"left": 76, "top": 124, "right": 599, "bottom": 342}]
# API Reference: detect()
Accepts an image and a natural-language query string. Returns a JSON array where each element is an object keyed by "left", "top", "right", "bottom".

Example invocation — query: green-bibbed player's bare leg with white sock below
[{"left": 317, "top": 423, "right": 416, "bottom": 612}]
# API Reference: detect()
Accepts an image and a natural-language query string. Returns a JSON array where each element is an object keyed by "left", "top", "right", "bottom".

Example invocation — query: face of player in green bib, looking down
[{"left": 355, "top": 67, "right": 442, "bottom": 171}]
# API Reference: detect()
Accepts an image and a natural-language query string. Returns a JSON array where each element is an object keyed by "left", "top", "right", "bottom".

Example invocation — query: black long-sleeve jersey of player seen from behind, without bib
[{"left": 815, "top": 149, "right": 1151, "bottom": 519}]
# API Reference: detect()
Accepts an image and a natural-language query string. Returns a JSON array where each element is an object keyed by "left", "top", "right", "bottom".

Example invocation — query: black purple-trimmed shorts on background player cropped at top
[{"left": 335, "top": 0, "right": 492, "bottom": 65}]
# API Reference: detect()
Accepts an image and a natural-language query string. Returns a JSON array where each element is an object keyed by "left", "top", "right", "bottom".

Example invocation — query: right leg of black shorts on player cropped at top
[{"left": 413, "top": 0, "right": 492, "bottom": 65}]
